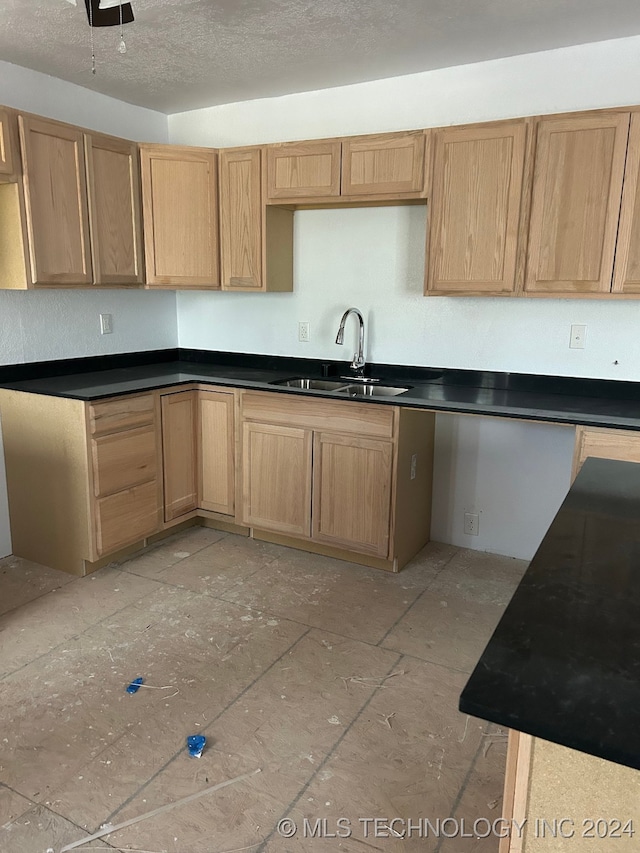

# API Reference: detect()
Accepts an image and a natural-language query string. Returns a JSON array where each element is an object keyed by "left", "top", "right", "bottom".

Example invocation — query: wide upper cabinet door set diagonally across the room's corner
[{"left": 140, "top": 145, "right": 220, "bottom": 288}]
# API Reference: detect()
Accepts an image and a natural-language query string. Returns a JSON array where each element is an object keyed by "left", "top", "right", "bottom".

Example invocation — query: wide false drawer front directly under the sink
[{"left": 242, "top": 392, "right": 396, "bottom": 438}]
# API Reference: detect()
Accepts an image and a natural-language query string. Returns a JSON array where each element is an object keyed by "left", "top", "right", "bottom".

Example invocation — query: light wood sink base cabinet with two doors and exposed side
[{"left": 239, "top": 392, "right": 435, "bottom": 571}]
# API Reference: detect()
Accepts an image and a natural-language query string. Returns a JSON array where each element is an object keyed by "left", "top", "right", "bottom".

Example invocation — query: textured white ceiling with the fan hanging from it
[{"left": 0, "top": 0, "right": 640, "bottom": 113}]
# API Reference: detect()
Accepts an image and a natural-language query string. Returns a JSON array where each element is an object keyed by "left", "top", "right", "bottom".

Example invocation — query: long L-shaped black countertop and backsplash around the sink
[{"left": 0, "top": 349, "right": 640, "bottom": 429}]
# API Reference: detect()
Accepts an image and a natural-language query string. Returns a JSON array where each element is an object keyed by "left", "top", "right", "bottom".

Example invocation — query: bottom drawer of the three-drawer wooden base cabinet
[{"left": 95, "top": 480, "right": 159, "bottom": 555}]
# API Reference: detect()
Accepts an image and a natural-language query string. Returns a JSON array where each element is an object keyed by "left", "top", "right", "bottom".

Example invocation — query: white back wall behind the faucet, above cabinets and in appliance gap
[{"left": 169, "top": 37, "right": 640, "bottom": 558}]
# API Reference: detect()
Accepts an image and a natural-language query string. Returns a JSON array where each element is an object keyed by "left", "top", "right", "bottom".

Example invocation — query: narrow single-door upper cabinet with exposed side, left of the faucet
[{"left": 218, "top": 148, "right": 293, "bottom": 291}]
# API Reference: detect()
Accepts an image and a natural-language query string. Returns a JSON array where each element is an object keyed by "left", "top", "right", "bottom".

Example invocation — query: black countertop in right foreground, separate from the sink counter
[{"left": 460, "top": 458, "right": 640, "bottom": 769}]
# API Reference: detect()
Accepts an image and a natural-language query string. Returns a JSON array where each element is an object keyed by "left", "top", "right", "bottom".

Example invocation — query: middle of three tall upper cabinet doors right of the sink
[{"left": 525, "top": 113, "right": 630, "bottom": 294}]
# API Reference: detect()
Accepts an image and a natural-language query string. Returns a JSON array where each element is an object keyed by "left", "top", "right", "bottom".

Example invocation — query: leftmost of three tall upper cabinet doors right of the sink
[{"left": 426, "top": 121, "right": 527, "bottom": 293}]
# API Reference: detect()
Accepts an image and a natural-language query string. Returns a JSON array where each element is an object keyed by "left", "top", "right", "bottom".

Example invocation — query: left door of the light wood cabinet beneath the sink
[{"left": 242, "top": 422, "right": 312, "bottom": 537}]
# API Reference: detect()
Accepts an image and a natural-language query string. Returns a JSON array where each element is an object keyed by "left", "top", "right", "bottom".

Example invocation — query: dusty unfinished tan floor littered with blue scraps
[{"left": 0, "top": 527, "right": 526, "bottom": 853}]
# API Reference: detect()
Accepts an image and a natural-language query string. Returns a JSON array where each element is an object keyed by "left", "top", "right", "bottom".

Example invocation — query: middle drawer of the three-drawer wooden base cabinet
[{"left": 91, "top": 425, "right": 157, "bottom": 498}]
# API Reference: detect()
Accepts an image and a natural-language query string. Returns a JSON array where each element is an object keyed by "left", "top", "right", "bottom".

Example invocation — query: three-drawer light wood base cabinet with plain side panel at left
[{"left": 0, "top": 390, "right": 162, "bottom": 575}]
